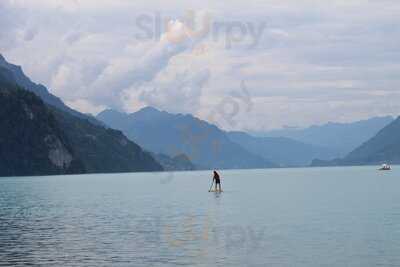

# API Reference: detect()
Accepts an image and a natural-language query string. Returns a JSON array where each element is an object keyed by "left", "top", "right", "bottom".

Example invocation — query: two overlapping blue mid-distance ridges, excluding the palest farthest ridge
[{"left": 97, "top": 107, "right": 346, "bottom": 168}]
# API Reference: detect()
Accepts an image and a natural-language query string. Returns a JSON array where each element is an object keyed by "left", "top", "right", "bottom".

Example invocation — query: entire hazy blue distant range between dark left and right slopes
[{"left": 97, "top": 107, "right": 393, "bottom": 168}]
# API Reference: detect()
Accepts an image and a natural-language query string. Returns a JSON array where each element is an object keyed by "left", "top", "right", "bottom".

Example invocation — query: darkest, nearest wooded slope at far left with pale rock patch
[{"left": 0, "top": 84, "right": 86, "bottom": 176}]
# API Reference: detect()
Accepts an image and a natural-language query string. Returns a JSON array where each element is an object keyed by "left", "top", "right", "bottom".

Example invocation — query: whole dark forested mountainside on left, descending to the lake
[{"left": 0, "top": 54, "right": 163, "bottom": 176}]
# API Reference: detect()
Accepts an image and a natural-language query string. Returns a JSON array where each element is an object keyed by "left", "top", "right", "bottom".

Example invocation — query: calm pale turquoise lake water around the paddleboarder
[{"left": 0, "top": 167, "right": 400, "bottom": 267}]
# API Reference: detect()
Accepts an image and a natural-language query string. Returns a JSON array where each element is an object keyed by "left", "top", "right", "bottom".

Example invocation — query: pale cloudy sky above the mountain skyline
[{"left": 0, "top": 0, "right": 400, "bottom": 132}]
